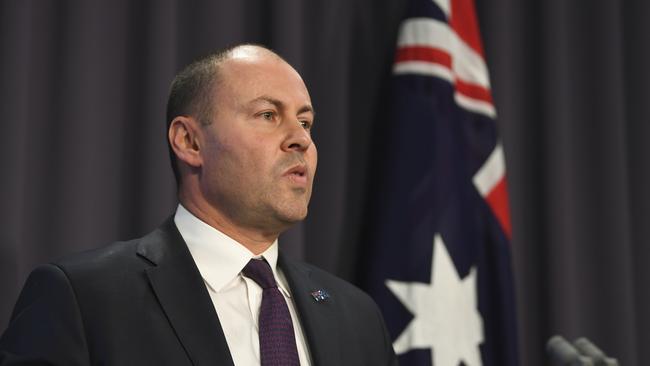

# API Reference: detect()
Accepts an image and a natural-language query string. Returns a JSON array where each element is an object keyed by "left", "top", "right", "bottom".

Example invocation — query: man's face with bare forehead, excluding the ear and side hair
[{"left": 200, "top": 52, "right": 317, "bottom": 232}]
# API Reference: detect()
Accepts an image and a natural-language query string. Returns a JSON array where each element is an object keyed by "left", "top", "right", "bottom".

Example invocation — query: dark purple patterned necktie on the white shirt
[{"left": 242, "top": 259, "right": 300, "bottom": 366}]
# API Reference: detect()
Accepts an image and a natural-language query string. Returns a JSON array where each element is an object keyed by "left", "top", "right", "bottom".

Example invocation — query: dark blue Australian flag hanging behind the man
[{"left": 361, "top": 0, "right": 518, "bottom": 366}]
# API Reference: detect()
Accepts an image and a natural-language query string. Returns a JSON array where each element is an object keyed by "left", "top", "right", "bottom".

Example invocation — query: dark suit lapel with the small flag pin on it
[{"left": 278, "top": 252, "right": 341, "bottom": 366}]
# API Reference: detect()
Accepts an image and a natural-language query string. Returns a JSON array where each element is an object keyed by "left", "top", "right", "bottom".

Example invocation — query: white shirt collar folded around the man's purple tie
[{"left": 174, "top": 204, "right": 290, "bottom": 296}]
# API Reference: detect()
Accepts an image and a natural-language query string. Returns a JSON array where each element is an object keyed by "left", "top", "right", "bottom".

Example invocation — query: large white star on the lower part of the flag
[{"left": 386, "top": 234, "right": 483, "bottom": 366}]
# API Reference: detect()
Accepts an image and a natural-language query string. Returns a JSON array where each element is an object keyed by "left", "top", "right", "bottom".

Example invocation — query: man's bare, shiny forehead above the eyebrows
[{"left": 217, "top": 54, "right": 311, "bottom": 105}]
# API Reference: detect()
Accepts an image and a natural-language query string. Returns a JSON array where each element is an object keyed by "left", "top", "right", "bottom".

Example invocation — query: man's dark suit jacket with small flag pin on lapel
[{"left": 0, "top": 219, "right": 397, "bottom": 366}]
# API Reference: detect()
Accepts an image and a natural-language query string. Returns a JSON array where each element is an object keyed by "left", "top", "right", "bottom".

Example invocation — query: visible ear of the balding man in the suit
[{"left": 167, "top": 116, "right": 203, "bottom": 168}]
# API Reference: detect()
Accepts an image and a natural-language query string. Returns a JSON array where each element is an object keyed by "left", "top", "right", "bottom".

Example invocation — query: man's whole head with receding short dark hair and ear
[{"left": 167, "top": 45, "right": 317, "bottom": 240}]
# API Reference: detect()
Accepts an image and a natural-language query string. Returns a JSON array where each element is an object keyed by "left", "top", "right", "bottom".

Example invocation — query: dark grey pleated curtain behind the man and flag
[{"left": 0, "top": 0, "right": 650, "bottom": 365}]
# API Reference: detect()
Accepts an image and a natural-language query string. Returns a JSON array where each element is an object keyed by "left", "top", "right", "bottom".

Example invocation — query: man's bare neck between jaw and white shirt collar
[{"left": 179, "top": 194, "right": 280, "bottom": 255}]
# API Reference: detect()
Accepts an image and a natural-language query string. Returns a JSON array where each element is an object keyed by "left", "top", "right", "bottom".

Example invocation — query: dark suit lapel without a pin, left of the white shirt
[{"left": 138, "top": 218, "right": 233, "bottom": 366}]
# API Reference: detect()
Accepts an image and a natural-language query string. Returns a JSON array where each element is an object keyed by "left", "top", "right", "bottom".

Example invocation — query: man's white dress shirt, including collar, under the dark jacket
[{"left": 174, "top": 205, "right": 310, "bottom": 366}]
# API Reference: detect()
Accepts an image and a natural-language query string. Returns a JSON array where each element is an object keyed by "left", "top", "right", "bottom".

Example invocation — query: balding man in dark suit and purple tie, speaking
[{"left": 0, "top": 45, "right": 397, "bottom": 366}]
